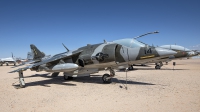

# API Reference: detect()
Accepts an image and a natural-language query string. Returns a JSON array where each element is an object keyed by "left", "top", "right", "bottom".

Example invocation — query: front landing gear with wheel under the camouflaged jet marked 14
[{"left": 102, "top": 67, "right": 115, "bottom": 83}]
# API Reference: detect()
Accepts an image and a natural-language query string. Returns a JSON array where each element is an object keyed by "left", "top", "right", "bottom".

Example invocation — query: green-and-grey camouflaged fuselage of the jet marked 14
[{"left": 32, "top": 39, "right": 176, "bottom": 74}]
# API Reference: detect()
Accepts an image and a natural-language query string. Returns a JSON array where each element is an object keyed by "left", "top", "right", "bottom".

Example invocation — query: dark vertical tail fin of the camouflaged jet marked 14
[{"left": 30, "top": 44, "right": 45, "bottom": 60}]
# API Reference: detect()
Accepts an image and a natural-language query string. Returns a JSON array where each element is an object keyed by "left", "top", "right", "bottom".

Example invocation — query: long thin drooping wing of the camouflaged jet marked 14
[{"left": 9, "top": 51, "right": 82, "bottom": 73}]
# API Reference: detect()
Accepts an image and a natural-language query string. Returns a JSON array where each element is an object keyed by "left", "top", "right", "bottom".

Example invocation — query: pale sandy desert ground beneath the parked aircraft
[{"left": 0, "top": 58, "right": 200, "bottom": 112}]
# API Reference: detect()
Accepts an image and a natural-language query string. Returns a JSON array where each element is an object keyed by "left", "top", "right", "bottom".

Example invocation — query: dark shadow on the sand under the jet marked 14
[{"left": 12, "top": 74, "right": 155, "bottom": 89}]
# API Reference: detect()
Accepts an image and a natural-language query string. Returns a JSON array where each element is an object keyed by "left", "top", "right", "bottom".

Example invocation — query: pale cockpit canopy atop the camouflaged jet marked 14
[{"left": 113, "top": 38, "right": 145, "bottom": 48}]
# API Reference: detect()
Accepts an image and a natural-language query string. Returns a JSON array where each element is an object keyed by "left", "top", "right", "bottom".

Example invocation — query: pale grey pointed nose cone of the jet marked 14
[{"left": 155, "top": 47, "right": 177, "bottom": 56}]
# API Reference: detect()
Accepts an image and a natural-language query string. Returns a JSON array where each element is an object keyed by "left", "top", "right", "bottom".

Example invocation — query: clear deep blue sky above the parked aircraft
[{"left": 0, "top": 0, "right": 200, "bottom": 58}]
